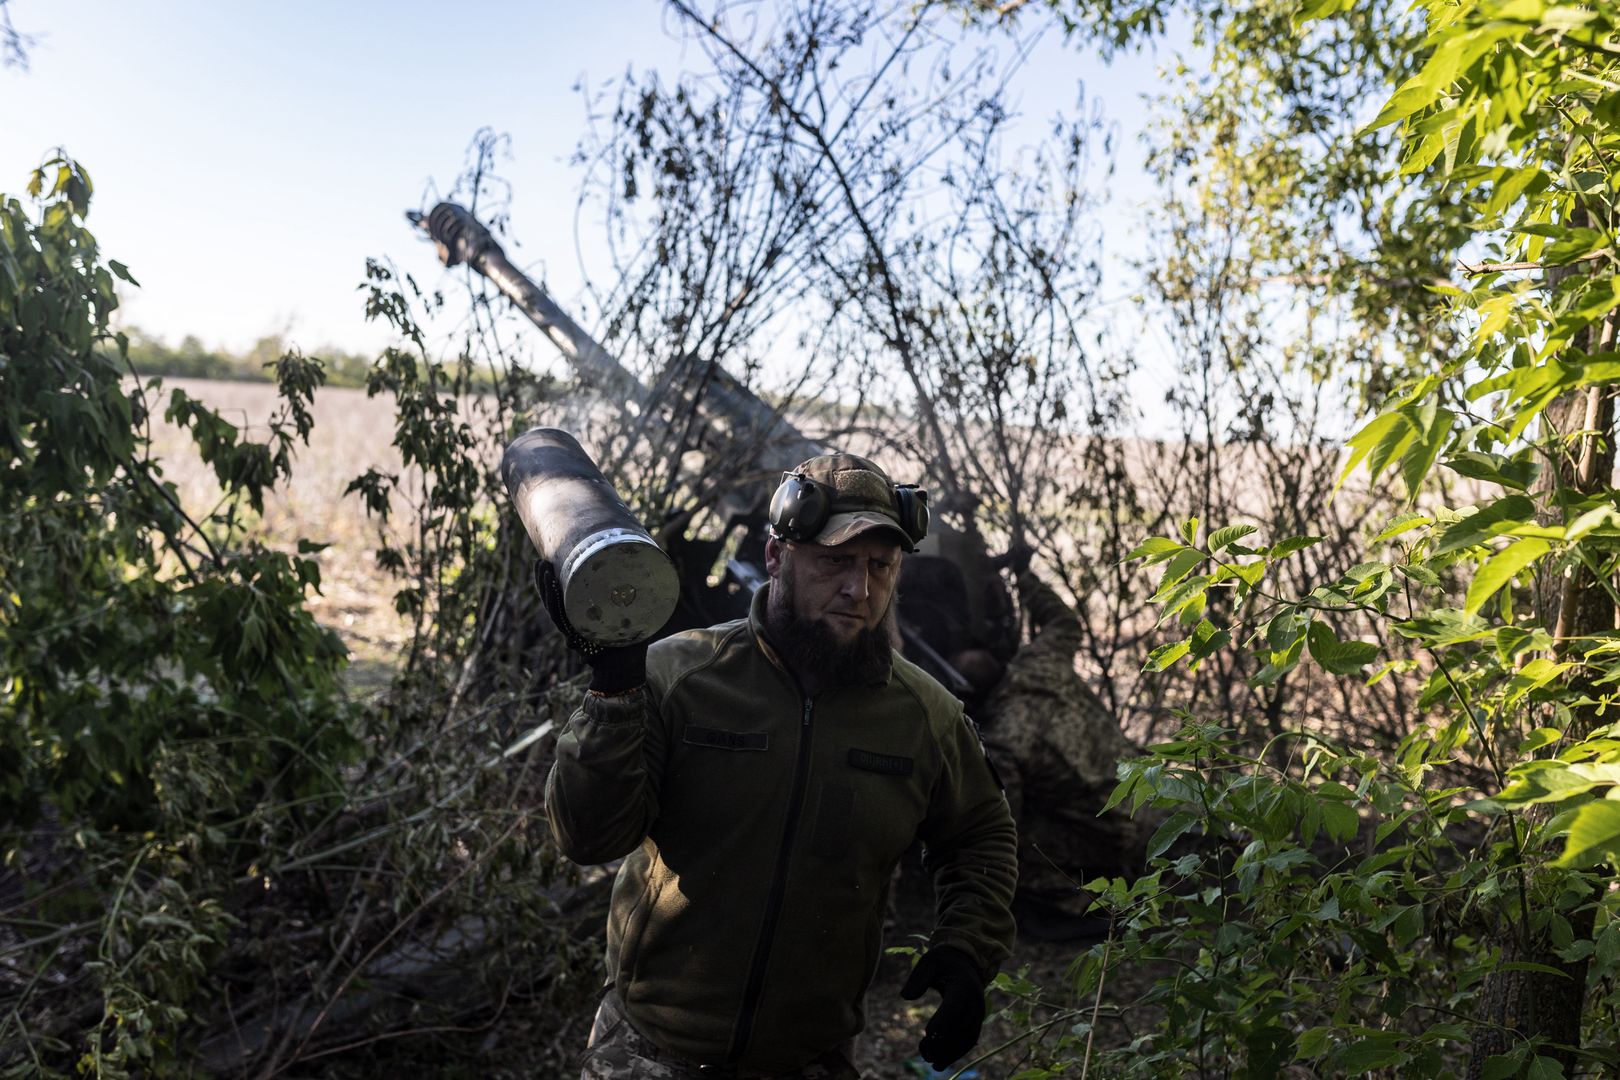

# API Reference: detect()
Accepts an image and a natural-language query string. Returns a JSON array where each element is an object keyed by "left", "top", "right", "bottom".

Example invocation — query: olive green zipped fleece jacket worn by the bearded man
[{"left": 546, "top": 586, "right": 1017, "bottom": 1072}]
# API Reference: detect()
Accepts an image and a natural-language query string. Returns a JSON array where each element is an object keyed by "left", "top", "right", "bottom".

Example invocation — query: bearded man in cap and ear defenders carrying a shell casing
[{"left": 546, "top": 453, "right": 1017, "bottom": 1080}]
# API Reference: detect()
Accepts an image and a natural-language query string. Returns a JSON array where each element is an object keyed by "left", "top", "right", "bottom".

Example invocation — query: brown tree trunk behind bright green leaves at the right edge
[{"left": 1468, "top": 293, "right": 1615, "bottom": 1080}]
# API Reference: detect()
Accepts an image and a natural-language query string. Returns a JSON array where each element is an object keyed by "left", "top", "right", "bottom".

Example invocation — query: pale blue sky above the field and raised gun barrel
[{"left": 0, "top": 0, "right": 1155, "bottom": 362}]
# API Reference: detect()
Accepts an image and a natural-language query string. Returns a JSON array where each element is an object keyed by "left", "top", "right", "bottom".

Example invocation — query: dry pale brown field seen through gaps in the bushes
[{"left": 142, "top": 379, "right": 1419, "bottom": 743}]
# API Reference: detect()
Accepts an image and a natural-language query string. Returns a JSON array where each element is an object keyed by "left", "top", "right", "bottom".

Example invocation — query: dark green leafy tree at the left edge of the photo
[{"left": 0, "top": 155, "right": 355, "bottom": 1075}]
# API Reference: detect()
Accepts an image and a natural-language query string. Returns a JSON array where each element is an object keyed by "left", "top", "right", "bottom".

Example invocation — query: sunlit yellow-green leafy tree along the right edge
[{"left": 1101, "top": 3, "right": 1620, "bottom": 1077}]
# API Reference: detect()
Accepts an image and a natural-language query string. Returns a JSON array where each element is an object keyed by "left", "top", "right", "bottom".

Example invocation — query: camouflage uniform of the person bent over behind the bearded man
[{"left": 985, "top": 570, "right": 1140, "bottom": 916}]
